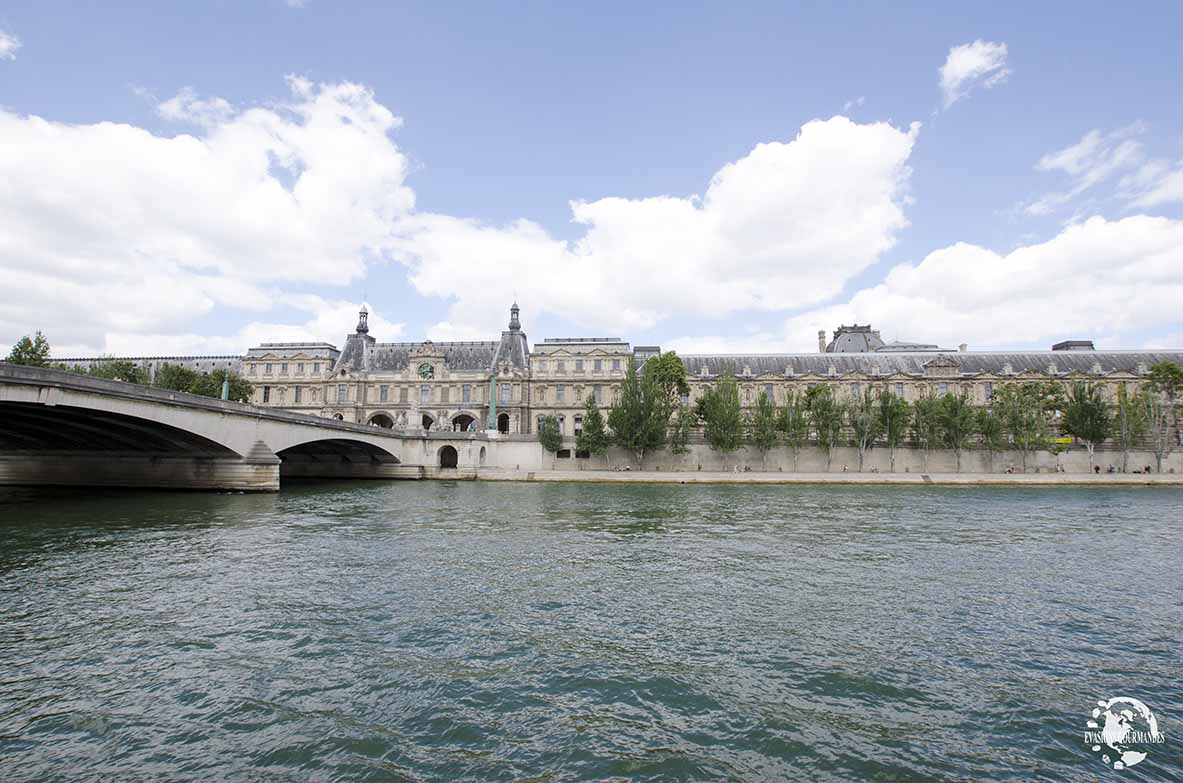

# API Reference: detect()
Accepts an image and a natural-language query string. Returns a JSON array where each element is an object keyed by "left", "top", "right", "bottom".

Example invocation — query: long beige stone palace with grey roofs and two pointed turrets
[{"left": 58, "top": 303, "right": 1183, "bottom": 436}]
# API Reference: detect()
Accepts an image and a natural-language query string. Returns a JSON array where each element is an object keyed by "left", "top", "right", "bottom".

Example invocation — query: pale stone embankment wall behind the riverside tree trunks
[{"left": 490, "top": 440, "right": 1183, "bottom": 474}]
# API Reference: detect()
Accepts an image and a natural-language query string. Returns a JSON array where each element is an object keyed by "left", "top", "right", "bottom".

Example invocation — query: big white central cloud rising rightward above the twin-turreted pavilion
[{"left": 399, "top": 117, "right": 919, "bottom": 336}]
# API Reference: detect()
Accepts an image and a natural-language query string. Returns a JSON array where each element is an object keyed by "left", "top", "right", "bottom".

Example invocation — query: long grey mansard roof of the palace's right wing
[{"left": 678, "top": 350, "right": 1183, "bottom": 377}]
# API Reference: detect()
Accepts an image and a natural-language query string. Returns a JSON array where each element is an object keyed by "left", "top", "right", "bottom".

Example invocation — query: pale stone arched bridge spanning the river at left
[{"left": 0, "top": 362, "right": 492, "bottom": 491}]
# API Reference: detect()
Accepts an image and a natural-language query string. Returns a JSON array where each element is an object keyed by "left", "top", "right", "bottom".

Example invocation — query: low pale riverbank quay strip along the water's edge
[{"left": 473, "top": 468, "right": 1183, "bottom": 486}]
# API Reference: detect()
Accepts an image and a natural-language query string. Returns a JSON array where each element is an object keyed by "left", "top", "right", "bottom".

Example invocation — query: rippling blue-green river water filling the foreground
[{"left": 0, "top": 481, "right": 1183, "bottom": 782}]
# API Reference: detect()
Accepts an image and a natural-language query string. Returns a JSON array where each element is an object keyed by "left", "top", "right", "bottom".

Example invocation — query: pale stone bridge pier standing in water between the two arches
[{"left": 0, "top": 452, "right": 279, "bottom": 492}]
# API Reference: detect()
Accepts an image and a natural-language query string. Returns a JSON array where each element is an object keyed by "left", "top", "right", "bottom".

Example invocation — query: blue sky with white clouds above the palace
[{"left": 0, "top": 0, "right": 1183, "bottom": 356}]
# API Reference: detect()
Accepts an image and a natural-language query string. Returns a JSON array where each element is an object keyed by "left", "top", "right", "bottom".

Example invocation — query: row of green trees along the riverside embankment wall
[{"left": 538, "top": 352, "right": 1183, "bottom": 471}]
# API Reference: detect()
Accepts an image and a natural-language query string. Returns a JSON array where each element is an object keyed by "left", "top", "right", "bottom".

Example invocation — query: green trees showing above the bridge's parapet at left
[{"left": 5, "top": 332, "right": 252, "bottom": 402}]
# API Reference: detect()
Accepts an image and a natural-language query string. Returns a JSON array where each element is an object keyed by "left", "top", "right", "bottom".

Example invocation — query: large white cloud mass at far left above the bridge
[{"left": 0, "top": 78, "right": 414, "bottom": 349}]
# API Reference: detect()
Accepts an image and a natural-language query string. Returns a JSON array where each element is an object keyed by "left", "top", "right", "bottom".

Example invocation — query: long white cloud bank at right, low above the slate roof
[{"left": 783, "top": 215, "right": 1183, "bottom": 350}]
